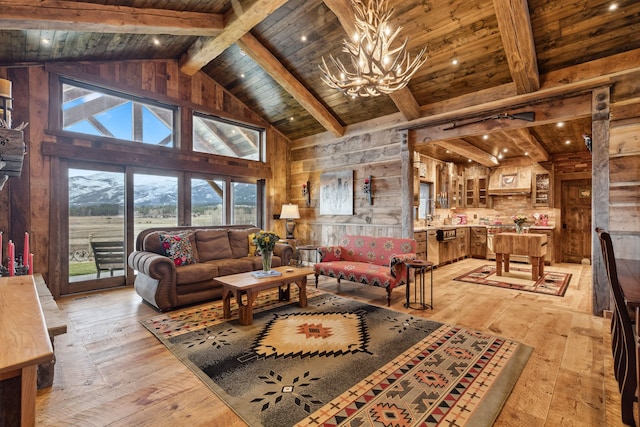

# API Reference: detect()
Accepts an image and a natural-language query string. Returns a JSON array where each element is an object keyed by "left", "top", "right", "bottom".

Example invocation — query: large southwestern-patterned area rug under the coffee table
[{"left": 142, "top": 289, "right": 532, "bottom": 427}]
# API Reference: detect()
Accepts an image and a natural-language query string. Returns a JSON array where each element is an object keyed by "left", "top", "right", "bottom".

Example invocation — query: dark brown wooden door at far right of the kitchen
[{"left": 560, "top": 179, "right": 591, "bottom": 263}]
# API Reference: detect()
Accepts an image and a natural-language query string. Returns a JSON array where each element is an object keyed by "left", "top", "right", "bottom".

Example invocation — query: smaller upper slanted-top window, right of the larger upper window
[{"left": 193, "top": 114, "right": 264, "bottom": 161}]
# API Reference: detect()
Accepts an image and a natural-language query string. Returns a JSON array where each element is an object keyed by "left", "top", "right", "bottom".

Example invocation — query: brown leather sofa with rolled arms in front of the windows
[{"left": 128, "top": 225, "right": 293, "bottom": 311}]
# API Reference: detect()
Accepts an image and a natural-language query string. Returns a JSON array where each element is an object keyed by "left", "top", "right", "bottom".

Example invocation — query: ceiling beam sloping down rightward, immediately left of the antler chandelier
[{"left": 238, "top": 33, "right": 344, "bottom": 136}]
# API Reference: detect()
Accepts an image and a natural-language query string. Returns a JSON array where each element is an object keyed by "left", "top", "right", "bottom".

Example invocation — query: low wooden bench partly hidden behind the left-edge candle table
[{"left": 33, "top": 273, "right": 67, "bottom": 389}]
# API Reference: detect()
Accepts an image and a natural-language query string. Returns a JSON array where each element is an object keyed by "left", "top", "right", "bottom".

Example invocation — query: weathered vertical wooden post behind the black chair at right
[{"left": 591, "top": 86, "right": 611, "bottom": 316}]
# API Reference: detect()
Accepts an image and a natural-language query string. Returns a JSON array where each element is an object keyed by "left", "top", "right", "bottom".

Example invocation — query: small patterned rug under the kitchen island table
[{"left": 454, "top": 265, "right": 571, "bottom": 297}]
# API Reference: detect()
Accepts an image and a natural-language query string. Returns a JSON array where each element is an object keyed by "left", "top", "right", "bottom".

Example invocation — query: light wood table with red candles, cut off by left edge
[{"left": 0, "top": 276, "right": 53, "bottom": 427}]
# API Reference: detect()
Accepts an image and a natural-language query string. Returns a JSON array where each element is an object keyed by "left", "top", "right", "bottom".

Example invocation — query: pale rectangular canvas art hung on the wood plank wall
[{"left": 320, "top": 171, "right": 353, "bottom": 215}]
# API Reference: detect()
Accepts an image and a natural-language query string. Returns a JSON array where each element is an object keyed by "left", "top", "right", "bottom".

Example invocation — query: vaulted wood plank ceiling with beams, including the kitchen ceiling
[{"left": 0, "top": 0, "right": 640, "bottom": 164}]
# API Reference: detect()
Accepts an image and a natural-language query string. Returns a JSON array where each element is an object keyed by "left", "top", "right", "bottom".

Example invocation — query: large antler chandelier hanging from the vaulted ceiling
[{"left": 320, "top": 0, "right": 427, "bottom": 97}]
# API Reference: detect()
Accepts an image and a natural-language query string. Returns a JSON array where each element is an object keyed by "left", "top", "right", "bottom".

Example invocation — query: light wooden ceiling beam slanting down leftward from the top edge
[{"left": 180, "top": 0, "right": 287, "bottom": 76}]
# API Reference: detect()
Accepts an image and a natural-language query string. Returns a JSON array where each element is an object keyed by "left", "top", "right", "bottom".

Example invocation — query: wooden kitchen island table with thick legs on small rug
[{"left": 493, "top": 233, "right": 547, "bottom": 281}]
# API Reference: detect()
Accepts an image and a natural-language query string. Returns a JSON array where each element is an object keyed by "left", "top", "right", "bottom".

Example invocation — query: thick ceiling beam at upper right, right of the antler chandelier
[{"left": 493, "top": 0, "right": 540, "bottom": 94}]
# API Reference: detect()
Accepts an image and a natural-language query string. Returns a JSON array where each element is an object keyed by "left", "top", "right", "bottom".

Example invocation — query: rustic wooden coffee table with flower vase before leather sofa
[{"left": 214, "top": 267, "right": 313, "bottom": 325}]
